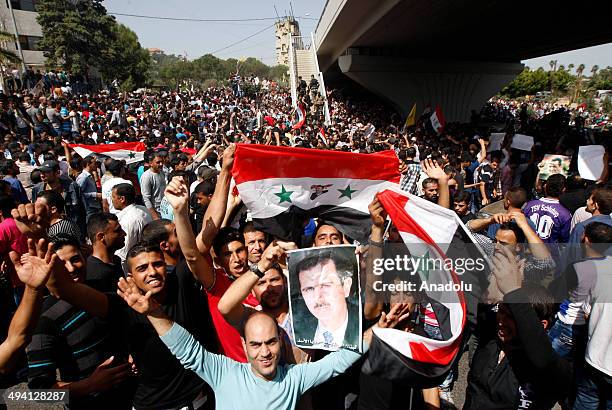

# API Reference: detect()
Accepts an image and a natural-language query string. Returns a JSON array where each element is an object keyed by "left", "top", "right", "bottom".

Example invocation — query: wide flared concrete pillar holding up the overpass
[{"left": 338, "top": 54, "right": 523, "bottom": 121}]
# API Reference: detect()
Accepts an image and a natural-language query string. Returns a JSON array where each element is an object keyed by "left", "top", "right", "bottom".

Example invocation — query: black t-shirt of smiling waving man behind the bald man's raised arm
[{"left": 108, "top": 261, "right": 217, "bottom": 409}]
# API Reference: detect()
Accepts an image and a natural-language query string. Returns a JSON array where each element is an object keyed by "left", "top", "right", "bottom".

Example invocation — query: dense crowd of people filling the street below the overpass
[{"left": 0, "top": 73, "right": 612, "bottom": 409}]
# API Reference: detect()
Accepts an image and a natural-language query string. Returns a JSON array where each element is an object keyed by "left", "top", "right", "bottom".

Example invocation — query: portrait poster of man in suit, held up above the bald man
[{"left": 288, "top": 245, "right": 362, "bottom": 351}]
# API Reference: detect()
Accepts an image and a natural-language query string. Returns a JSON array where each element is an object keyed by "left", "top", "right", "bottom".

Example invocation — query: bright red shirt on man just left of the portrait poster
[{"left": 206, "top": 269, "right": 259, "bottom": 363}]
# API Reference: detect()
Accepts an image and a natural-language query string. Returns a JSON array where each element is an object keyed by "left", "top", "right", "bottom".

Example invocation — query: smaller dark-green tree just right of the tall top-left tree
[{"left": 100, "top": 22, "right": 151, "bottom": 91}]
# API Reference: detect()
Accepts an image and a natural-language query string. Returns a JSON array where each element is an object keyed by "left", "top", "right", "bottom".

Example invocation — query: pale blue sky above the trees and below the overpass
[{"left": 104, "top": 0, "right": 612, "bottom": 75}]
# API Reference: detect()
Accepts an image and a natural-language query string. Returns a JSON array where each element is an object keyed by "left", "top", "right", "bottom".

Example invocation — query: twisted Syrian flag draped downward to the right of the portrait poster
[{"left": 363, "top": 188, "right": 466, "bottom": 388}]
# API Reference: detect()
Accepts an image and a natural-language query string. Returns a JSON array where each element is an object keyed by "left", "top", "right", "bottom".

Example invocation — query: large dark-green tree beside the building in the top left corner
[{"left": 36, "top": 0, "right": 115, "bottom": 74}]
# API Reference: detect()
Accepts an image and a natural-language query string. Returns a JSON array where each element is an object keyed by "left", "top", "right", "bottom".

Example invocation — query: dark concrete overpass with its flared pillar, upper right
[{"left": 314, "top": 0, "right": 612, "bottom": 121}]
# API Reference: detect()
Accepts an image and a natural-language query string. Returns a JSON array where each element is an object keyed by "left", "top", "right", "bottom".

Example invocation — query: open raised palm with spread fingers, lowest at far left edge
[{"left": 9, "top": 238, "right": 58, "bottom": 289}]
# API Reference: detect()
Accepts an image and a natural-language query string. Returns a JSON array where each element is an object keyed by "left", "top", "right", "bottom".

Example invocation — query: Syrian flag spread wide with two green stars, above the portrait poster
[{"left": 232, "top": 144, "right": 400, "bottom": 243}]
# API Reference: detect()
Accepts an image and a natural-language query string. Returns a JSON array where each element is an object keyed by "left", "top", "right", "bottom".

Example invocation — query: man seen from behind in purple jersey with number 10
[{"left": 523, "top": 174, "right": 572, "bottom": 243}]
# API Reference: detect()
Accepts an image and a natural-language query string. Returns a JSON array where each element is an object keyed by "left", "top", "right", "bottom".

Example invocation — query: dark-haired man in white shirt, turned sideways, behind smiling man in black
[{"left": 111, "top": 183, "right": 153, "bottom": 272}]
